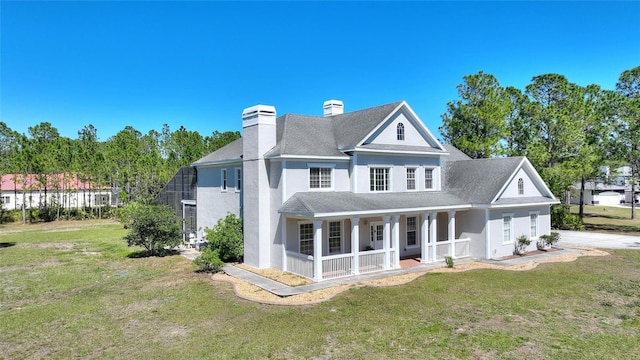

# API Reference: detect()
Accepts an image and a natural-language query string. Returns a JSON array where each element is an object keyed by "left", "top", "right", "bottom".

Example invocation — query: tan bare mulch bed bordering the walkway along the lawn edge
[{"left": 211, "top": 247, "right": 609, "bottom": 305}]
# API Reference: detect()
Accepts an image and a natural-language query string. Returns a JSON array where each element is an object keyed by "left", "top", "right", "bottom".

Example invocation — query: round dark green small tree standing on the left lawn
[{"left": 124, "top": 205, "right": 182, "bottom": 255}]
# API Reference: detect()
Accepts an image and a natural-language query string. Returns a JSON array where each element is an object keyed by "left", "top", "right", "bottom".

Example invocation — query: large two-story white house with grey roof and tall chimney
[{"left": 192, "top": 100, "right": 558, "bottom": 281}]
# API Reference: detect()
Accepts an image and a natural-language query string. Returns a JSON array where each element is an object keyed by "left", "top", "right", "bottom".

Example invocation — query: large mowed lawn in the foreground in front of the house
[{"left": 0, "top": 222, "right": 640, "bottom": 359}]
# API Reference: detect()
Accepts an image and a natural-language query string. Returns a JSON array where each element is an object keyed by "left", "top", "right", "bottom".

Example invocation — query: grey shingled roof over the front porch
[{"left": 279, "top": 191, "right": 471, "bottom": 217}]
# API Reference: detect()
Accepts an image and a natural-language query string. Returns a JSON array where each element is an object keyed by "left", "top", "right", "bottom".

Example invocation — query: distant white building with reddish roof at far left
[{"left": 0, "top": 174, "right": 113, "bottom": 210}]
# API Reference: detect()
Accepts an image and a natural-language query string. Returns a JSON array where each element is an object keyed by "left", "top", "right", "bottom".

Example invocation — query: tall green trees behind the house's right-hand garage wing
[{"left": 439, "top": 66, "right": 640, "bottom": 219}]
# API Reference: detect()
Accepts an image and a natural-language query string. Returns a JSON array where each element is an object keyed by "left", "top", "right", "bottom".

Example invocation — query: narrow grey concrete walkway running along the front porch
[{"left": 215, "top": 249, "right": 583, "bottom": 297}]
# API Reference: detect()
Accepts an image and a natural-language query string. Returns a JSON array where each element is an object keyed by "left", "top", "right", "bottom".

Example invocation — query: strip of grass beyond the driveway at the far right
[{"left": 571, "top": 205, "right": 640, "bottom": 236}]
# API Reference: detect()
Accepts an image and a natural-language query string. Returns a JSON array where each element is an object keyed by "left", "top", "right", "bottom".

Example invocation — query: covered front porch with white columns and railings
[{"left": 282, "top": 210, "right": 470, "bottom": 281}]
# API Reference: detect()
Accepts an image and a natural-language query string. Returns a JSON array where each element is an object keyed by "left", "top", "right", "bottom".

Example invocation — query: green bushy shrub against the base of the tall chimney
[{"left": 205, "top": 213, "right": 244, "bottom": 262}]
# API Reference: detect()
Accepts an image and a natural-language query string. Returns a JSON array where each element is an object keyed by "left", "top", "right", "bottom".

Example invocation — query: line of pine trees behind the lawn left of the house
[{"left": 0, "top": 122, "right": 240, "bottom": 221}]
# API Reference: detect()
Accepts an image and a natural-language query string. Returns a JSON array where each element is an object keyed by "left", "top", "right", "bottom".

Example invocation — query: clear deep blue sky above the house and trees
[{"left": 0, "top": 1, "right": 640, "bottom": 140}]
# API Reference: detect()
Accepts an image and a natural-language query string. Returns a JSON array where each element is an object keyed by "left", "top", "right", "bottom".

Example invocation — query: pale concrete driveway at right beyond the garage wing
[{"left": 557, "top": 230, "right": 640, "bottom": 250}]
